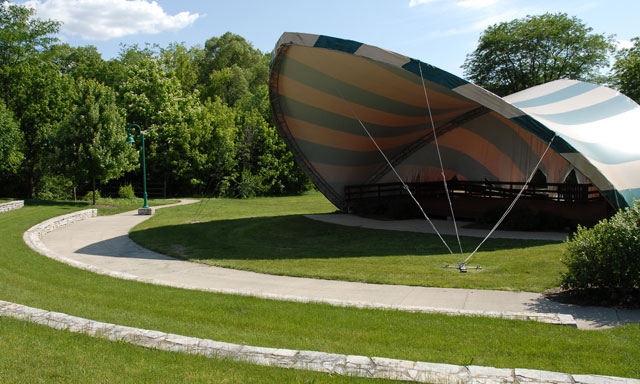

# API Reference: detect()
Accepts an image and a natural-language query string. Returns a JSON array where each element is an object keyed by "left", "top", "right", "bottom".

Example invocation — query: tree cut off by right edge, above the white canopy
[{"left": 611, "top": 37, "right": 640, "bottom": 103}]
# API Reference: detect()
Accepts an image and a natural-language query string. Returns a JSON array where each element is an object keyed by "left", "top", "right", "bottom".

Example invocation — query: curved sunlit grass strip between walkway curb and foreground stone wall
[{"left": 0, "top": 199, "right": 640, "bottom": 382}]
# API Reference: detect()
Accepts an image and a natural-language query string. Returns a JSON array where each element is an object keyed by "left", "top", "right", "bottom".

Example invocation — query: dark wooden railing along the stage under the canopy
[{"left": 344, "top": 180, "right": 601, "bottom": 202}]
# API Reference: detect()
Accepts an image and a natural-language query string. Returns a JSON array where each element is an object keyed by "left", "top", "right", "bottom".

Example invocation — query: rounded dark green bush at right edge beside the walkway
[{"left": 562, "top": 201, "right": 640, "bottom": 303}]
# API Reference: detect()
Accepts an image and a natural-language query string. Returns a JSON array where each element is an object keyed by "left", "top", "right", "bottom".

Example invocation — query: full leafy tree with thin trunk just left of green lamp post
[{"left": 55, "top": 79, "right": 138, "bottom": 205}]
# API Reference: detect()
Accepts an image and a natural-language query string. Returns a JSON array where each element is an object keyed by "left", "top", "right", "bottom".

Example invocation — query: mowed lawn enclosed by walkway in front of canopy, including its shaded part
[{"left": 130, "top": 193, "right": 565, "bottom": 292}]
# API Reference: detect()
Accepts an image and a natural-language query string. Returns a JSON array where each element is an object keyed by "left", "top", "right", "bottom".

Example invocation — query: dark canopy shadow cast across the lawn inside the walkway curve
[{"left": 125, "top": 215, "right": 557, "bottom": 260}]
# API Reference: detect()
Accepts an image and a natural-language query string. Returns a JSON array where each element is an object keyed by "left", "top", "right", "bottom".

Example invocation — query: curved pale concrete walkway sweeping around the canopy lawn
[{"left": 37, "top": 201, "right": 640, "bottom": 328}]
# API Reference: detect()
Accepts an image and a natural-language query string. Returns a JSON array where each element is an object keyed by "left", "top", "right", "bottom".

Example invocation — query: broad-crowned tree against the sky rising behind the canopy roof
[{"left": 462, "top": 13, "right": 613, "bottom": 96}]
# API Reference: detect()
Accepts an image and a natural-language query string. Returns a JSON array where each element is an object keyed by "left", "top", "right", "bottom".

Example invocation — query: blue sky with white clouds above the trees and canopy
[{"left": 12, "top": 0, "right": 640, "bottom": 76}]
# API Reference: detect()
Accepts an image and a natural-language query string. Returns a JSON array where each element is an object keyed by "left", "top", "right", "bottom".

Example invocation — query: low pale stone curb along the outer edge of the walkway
[{"left": 23, "top": 209, "right": 578, "bottom": 328}]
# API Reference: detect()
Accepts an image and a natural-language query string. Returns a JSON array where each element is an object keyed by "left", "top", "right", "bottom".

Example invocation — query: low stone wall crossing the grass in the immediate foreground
[{"left": 0, "top": 301, "right": 640, "bottom": 384}]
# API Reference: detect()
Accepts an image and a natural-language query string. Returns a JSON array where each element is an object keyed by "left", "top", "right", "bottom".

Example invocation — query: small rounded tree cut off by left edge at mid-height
[{"left": 0, "top": 102, "right": 24, "bottom": 176}]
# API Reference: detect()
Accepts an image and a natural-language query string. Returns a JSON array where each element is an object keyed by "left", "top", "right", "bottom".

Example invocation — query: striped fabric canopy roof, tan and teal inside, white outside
[{"left": 269, "top": 33, "right": 640, "bottom": 212}]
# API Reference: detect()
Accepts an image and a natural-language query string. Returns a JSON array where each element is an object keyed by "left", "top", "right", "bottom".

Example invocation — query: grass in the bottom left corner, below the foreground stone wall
[{"left": 0, "top": 318, "right": 391, "bottom": 384}]
